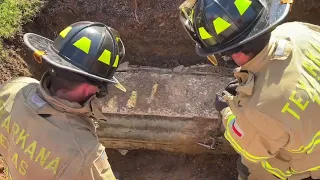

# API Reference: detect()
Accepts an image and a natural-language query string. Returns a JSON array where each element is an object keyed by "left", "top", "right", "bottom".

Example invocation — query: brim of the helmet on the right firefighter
[{"left": 196, "top": 0, "right": 290, "bottom": 57}]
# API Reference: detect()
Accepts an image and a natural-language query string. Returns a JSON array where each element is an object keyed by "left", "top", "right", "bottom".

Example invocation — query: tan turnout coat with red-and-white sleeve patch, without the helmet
[{"left": 222, "top": 22, "right": 320, "bottom": 179}]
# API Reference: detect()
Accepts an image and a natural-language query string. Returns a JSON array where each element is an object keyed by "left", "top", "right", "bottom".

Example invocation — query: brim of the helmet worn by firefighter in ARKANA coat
[{"left": 23, "top": 33, "right": 119, "bottom": 84}]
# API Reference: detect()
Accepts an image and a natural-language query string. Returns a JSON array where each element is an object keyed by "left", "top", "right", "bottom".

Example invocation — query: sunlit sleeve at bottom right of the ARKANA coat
[{"left": 78, "top": 145, "right": 116, "bottom": 180}]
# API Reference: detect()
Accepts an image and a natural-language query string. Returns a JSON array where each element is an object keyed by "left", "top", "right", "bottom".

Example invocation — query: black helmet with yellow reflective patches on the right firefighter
[{"left": 180, "top": 0, "right": 292, "bottom": 56}]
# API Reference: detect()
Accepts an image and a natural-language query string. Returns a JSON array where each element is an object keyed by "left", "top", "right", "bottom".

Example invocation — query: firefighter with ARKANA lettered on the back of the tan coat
[{"left": 0, "top": 21, "right": 125, "bottom": 180}]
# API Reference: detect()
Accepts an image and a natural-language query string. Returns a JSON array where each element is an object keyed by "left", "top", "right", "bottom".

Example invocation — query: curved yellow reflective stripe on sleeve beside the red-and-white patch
[{"left": 224, "top": 115, "right": 268, "bottom": 163}]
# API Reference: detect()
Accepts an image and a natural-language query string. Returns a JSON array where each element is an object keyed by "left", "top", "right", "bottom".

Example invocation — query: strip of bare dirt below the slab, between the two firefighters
[{"left": 107, "top": 149, "right": 238, "bottom": 180}]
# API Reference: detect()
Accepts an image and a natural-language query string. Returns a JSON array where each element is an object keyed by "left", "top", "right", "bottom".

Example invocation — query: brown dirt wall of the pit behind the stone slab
[{"left": 24, "top": 0, "right": 320, "bottom": 68}]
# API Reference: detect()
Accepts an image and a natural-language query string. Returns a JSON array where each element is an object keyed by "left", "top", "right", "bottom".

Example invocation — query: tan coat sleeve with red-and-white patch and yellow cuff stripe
[{"left": 221, "top": 107, "right": 289, "bottom": 163}]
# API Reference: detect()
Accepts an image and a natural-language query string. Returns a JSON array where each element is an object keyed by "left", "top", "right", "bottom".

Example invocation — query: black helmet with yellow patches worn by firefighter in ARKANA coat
[{"left": 24, "top": 21, "right": 125, "bottom": 83}]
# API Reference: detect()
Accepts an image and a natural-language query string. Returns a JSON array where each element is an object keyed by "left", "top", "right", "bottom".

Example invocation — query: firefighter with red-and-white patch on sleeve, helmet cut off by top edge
[{"left": 180, "top": 0, "right": 320, "bottom": 180}]
